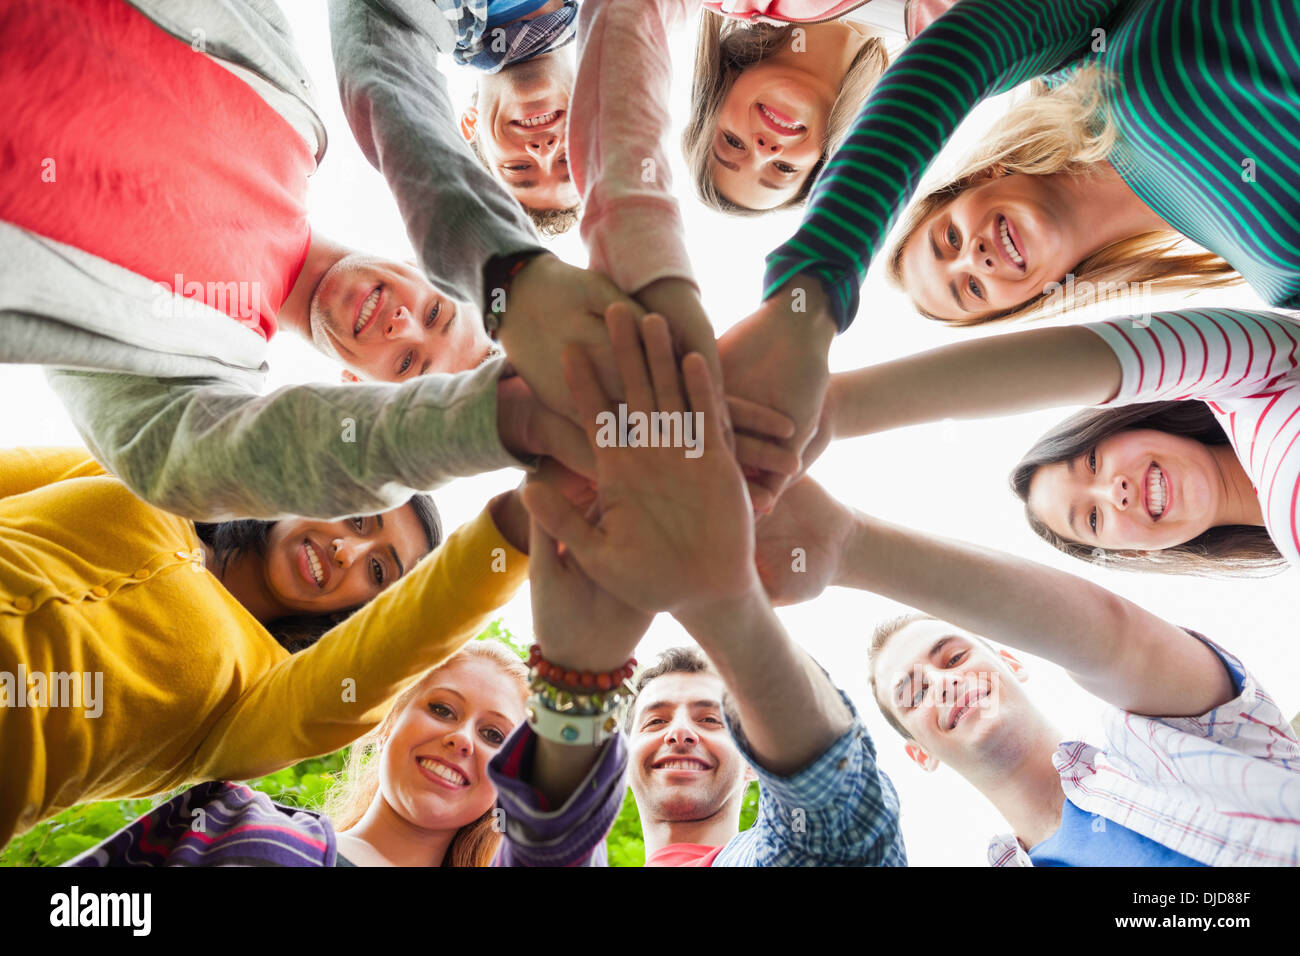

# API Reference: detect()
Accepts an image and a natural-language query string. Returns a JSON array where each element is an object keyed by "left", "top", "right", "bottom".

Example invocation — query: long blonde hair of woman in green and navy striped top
[{"left": 887, "top": 66, "right": 1242, "bottom": 325}]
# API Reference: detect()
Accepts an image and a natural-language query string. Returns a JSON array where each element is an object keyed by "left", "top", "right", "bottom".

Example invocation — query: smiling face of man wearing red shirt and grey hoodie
[{"left": 309, "top": 254, "right": 494, "bottom": 381}]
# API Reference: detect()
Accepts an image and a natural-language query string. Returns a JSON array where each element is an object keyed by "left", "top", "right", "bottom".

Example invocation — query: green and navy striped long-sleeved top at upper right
[{"left": 763, "top": 0, "right": 1300, "bottom": 332}]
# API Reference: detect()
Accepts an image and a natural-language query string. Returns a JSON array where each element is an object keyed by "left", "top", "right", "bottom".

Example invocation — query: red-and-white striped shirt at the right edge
[{"left": 1083, "top": 308, "right": 1300, "bottom": 567}]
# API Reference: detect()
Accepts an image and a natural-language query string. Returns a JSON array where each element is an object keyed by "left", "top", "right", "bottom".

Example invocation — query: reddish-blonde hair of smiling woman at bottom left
[{"left": 322, "top": 640, "right": 528, "bottom": 866}]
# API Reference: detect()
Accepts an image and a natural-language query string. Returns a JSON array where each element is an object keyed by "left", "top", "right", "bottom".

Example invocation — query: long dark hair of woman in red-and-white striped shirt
[{"left": 1011, "top": 401, "right": 1287, "bottom": 578}]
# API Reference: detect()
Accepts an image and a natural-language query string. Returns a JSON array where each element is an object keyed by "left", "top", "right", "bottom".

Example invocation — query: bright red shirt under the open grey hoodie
[{"left": 0, "top": 0, "right": 315, "bottom": 338}]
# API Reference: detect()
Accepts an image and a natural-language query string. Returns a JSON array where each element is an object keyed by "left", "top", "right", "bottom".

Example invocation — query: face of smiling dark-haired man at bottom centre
[{"left": 628, "top": 674, "right": 745, "bottom": 822}]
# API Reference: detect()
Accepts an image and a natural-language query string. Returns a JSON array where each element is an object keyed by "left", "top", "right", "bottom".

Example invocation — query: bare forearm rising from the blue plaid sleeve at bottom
[{"left": 679, "top": 588, "right": 853, "bottom": 775}]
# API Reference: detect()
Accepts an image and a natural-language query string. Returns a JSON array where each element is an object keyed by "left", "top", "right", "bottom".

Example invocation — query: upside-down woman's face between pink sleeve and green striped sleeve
[{"left": 709, "top": 61, "right": 836, "bottom": 209}]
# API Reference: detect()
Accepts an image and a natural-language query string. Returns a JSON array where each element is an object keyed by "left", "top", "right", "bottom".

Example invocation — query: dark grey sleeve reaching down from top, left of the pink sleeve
[{"left": 330, "top": 0, "right": 541, "bottom": 311}]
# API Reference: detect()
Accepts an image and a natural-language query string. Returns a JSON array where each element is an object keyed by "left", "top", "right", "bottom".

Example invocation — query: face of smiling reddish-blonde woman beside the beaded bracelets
[{"left": 380, "top": 657, "right": 524, "bottom": 830}]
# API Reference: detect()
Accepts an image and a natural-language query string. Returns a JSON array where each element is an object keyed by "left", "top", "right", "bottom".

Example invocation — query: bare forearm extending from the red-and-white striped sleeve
[{"left": 827, "top": 326, "right": 1119, "bottom": 438}]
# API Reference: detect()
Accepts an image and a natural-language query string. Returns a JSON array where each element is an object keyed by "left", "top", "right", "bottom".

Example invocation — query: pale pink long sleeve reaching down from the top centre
[{"left": 568, "top": 0, "right": 699, "bottom": 293}]
